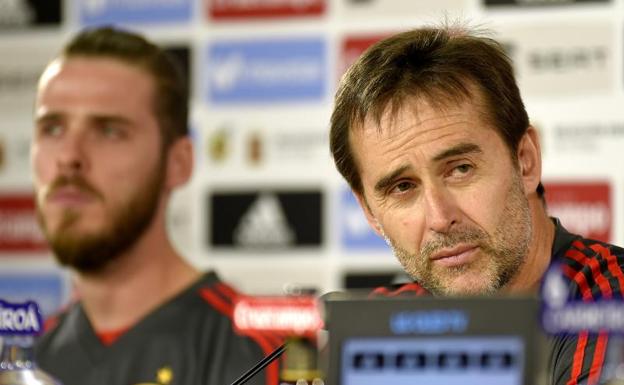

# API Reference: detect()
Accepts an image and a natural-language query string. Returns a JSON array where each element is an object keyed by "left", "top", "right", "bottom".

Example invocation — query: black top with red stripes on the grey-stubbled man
[{"left": 372, "top": 219, "right": 624, "bottom": 385}]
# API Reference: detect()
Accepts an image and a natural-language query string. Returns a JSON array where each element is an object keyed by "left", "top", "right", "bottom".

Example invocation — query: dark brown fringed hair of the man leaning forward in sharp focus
[{"left": 330, "top": 25, "right": 544, "bottom": 197}]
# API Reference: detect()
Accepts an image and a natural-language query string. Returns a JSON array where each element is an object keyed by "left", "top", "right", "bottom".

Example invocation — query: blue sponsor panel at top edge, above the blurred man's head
[{"left": 76, "top": 0, "right": 192, "bottom": 25}]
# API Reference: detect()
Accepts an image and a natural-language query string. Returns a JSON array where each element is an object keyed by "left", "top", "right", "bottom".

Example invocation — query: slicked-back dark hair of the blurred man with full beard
[{"left": 61, "top": 26, "right": 189, "bottom": 149}]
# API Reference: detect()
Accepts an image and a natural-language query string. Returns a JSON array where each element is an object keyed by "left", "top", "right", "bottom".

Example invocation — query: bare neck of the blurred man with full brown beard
[{"left": 75, "top": 219, "right": 200, "bottom": 331}]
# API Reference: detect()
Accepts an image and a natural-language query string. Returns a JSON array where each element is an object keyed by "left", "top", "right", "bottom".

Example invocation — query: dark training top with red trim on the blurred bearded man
[{"left": 35, "top": 272, "right": 282, "bottom": 385}]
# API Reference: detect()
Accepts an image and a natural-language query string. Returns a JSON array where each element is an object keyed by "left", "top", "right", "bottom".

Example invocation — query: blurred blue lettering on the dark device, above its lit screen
[{"left": 390, "top": 310, "right": 468, "bottom": 334}]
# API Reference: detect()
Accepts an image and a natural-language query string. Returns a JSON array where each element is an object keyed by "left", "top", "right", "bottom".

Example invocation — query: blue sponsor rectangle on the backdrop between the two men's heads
[{"left": 210, "top": 38, "right": 326, "bottom": 104}]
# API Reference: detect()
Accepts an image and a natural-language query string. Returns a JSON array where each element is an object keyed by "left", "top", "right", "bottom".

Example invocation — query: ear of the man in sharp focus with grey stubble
[{"left": 517, "top": 126, "right": 542, "bottom": 195}]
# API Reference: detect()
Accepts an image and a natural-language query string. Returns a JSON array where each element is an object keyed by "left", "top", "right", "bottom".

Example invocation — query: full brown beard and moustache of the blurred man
[{"left": 37, "top": 160, "right": 164, "bottom": 274}]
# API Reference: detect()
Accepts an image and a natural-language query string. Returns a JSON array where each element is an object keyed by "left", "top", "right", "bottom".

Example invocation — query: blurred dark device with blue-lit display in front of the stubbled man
[{"left": 325, "top": 297, "right": 544, "bottom": 385}]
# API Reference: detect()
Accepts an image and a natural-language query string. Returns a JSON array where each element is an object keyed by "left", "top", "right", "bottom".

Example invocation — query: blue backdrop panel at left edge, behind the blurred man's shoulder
[{"left": 0, "top": 271, "right": 69, "bottom": 317}]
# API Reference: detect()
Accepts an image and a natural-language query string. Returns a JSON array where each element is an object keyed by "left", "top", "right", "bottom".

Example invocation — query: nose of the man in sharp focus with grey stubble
[{"left": 424, "top": 186, "right": 459, "bottom": 233}]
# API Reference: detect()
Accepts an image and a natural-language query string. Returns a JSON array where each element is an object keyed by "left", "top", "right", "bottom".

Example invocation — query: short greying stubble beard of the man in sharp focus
[{"left": 384, "top": 173, "right": 532, "bottom": 295}]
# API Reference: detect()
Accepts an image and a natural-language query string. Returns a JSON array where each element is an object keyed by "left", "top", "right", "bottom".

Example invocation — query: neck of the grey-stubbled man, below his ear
[{"left": 506, "top": 200, "right": 555, "bottom": 293}]
